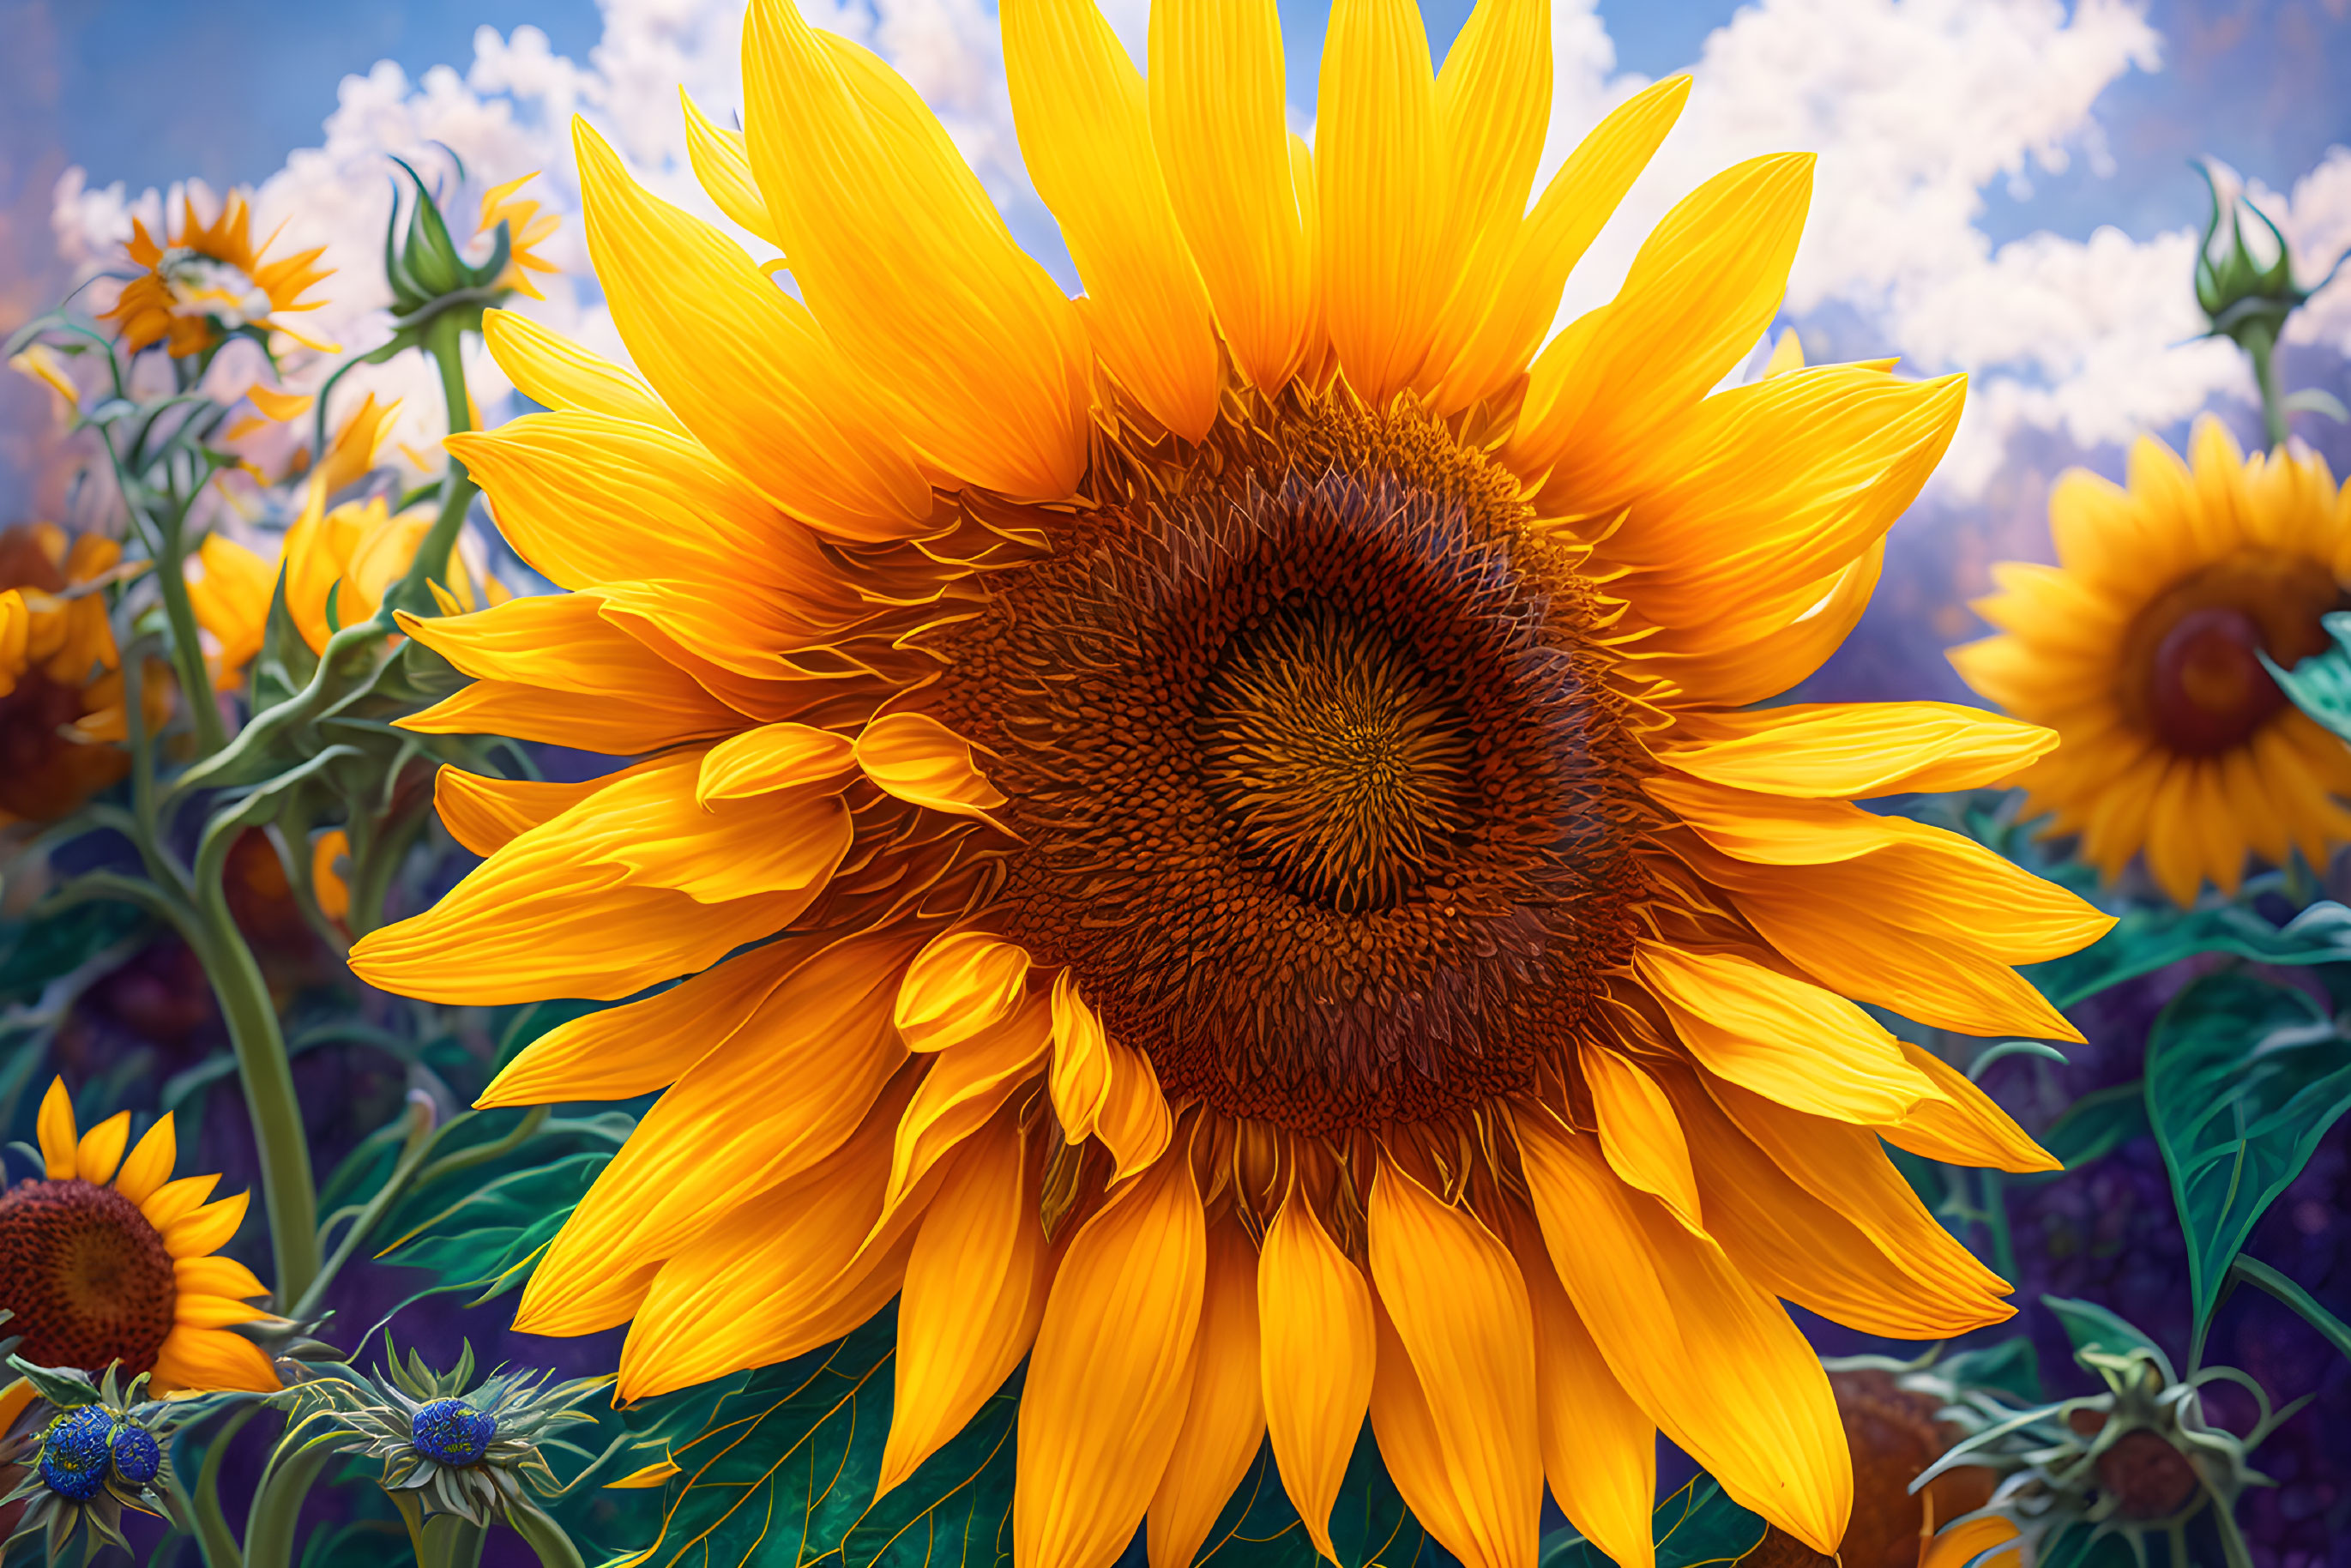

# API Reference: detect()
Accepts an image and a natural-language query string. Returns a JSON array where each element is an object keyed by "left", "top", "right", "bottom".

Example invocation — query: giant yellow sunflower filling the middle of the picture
[{"left": 353, "top": 0, "right": 2109, "bottom": 1568}]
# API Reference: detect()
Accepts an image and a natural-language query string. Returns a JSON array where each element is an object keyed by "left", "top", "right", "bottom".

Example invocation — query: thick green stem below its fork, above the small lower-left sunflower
[{"left": 196, "top": 853, "right": 320, "bottom": 1302}]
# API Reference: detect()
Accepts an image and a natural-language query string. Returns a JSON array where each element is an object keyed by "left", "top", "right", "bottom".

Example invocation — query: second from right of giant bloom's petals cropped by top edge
[{"left": 1314, "top": 0, "right": 1465, "bottom": 409}]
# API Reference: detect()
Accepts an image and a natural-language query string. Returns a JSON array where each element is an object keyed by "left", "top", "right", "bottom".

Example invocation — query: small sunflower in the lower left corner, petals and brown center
[{"left": 0, "top": 1079, "right": 277, "bottom": 1391}]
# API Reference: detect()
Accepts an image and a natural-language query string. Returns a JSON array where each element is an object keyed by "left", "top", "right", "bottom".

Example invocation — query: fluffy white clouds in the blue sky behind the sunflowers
[{"left": 57, "top": 0, "right": 2351, "bottom": 510}]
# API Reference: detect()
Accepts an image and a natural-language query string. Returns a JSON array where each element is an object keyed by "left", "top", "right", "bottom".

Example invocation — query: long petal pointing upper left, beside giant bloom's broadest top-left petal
[{"left": 571, "top": 120, "right": 931, "bottom": 539}]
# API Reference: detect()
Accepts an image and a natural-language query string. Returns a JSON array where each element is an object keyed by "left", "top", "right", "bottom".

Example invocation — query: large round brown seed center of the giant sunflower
[{"left": 926, "top": 395, "right": 1646, "bottom": 1133}]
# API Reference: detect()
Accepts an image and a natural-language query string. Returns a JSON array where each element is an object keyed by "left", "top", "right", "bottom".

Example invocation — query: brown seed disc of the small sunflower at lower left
[{"left": 0, "top": 1180, "right": 178, "bottom": 1375}]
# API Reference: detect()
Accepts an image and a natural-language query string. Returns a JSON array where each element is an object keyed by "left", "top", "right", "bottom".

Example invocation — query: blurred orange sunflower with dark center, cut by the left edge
[{"left": 0, "top": 522, "right": 172, "bottom": 828}]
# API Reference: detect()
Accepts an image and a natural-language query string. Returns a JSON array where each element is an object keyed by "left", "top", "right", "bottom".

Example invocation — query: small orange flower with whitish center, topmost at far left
[{"left": 99, "top": 190, "right": 336, "bottom": 359}]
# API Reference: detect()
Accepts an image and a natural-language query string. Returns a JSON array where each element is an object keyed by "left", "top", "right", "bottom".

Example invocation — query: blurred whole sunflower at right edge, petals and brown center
[{"left": 1951, "top": 416, "right": 2351, "bottom": 905}]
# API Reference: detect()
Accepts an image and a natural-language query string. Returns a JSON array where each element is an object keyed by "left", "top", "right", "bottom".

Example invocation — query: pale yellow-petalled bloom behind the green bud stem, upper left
[{"left": 188, "top": 393, "right": 508, "bottom": 691}]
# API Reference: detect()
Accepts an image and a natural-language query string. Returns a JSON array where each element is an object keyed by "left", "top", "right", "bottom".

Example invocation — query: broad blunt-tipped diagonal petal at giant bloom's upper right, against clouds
[{"left": 1504, "top": 153, "right": 1812, "bottom": 512}]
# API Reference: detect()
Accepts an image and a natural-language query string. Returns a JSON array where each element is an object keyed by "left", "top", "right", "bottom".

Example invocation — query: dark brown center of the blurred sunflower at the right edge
[{"left": 2123, "top": 552, "right": 2344, "bottom": 757}]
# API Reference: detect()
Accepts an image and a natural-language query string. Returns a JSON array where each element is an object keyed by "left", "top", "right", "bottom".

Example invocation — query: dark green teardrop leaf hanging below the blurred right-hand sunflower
[{"left": 2147, "top": 974, "right": 2351, "bottom": 1345}]
